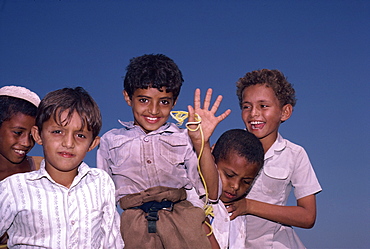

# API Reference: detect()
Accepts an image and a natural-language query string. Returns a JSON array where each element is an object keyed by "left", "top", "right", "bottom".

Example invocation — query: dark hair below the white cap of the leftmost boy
[{"left": 0, "top": 95, "right": 37, "bottom": 126}]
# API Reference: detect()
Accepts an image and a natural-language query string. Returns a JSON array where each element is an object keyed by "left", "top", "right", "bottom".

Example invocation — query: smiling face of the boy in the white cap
[{"left": 0, "top": 112, "right": 35, "bottom": 164}]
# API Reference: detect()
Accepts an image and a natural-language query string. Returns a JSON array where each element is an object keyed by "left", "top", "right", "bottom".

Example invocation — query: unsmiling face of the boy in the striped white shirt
[{"left": 32, "top": 110, "right": 99, "bottom": 181}]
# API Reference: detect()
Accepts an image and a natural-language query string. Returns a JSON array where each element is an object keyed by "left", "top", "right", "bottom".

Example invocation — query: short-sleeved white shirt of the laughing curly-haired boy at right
[{"left": 246, "top": 134, "right": 321, "bottom": 248}]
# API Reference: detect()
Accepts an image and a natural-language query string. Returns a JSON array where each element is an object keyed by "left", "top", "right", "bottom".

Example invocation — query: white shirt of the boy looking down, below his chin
[{"left": 212, "top": 201, "right": 247, "bottom": 249}]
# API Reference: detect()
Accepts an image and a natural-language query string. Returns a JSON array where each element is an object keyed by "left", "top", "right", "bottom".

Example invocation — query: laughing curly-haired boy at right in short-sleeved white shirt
[{"left": 228, "top": 69, "right": 321, "bottom": 248}]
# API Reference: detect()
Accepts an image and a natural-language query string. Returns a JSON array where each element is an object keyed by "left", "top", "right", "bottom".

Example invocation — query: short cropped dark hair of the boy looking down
[{"left": 212, "top": 129, "right": 264, "bottom": 168}]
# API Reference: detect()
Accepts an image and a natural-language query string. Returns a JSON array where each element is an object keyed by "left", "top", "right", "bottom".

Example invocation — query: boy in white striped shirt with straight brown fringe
[{"left": 0, "top": 87, "right": 123, "bottom": 248}]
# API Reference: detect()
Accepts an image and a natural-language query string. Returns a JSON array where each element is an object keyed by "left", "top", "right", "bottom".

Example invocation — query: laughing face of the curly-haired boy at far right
[{"left": 242, "top": 84, "right": 292, "bottom": 148}]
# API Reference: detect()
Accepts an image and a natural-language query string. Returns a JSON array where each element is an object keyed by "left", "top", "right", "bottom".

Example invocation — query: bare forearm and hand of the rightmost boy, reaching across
[{"left": 227, "top": 195, "right": 316, "bottom": 228}]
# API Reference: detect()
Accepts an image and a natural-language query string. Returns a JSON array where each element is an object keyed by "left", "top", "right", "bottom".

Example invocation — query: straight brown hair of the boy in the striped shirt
[{"left": 36, "top": 87, "right": 102, "bottom": 138}]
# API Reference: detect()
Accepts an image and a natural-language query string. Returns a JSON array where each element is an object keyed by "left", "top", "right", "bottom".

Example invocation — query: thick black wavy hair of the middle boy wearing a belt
[{"left": 123, "top": 54, "right": 184, "bottom": 100}]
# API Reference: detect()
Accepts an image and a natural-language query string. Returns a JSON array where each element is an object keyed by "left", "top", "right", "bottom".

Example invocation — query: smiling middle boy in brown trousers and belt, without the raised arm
[{"left": 97, "top": 54, "right": 218, "bottom": 248}]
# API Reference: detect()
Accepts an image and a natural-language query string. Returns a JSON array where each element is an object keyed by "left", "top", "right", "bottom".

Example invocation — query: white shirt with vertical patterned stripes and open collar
[{"left": 0, "top": 161, "right": 124, "bottom": 249}]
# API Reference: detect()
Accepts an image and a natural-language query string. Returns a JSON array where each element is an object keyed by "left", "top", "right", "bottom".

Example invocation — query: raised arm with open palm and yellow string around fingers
[{"left": 188, "top": 89, "right": 231, "bottom": 200}]
